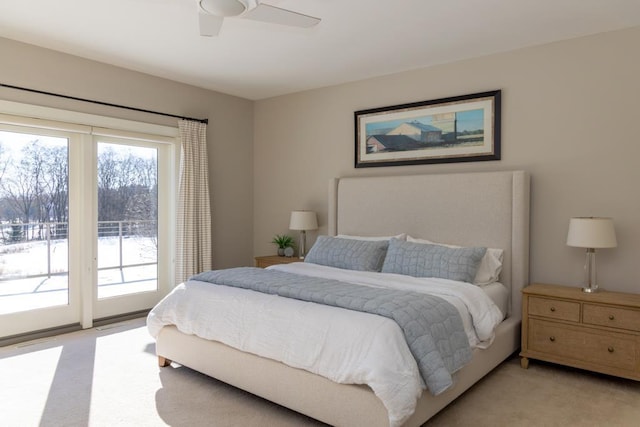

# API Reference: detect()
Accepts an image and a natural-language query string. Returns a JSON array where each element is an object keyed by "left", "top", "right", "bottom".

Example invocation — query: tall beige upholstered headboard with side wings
[{"left": 329, "top": 171, "right": 530, "bottom": 317}]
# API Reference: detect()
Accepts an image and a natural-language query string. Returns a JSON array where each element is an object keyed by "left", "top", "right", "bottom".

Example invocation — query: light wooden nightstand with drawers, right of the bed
[{"left": 520, "top": 284, "right": 640, "bottom": 380}]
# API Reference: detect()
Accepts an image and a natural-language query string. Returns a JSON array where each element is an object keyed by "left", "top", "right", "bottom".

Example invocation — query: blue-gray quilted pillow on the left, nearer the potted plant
[{"left": 304, "top": 236, "right": 389, "bottom": 271}]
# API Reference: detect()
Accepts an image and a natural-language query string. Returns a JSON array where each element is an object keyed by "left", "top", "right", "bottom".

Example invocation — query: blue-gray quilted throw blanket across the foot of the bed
[{"left": 190, "top": 267, "right": 471, "bottom": 395}]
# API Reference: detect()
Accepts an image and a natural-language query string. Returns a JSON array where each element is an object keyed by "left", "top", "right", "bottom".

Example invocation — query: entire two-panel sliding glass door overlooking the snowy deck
[{"left": 0, "top": 119, "right": 176, "bottom": 339}]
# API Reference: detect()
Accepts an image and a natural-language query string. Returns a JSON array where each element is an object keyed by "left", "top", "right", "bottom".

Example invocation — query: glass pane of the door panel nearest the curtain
[{"left": 97, "top": 142, "right": 158, "bottom": 298}]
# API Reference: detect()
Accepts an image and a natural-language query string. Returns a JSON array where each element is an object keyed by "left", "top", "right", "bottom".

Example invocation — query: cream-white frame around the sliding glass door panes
[{"left": 0, "top": 100, "right": 180, "bottom": 335}]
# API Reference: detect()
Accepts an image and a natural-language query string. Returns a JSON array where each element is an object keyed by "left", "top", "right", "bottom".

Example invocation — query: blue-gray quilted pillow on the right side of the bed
[{"left": 382, "top": 239, "right": 487, "bottom": 283}]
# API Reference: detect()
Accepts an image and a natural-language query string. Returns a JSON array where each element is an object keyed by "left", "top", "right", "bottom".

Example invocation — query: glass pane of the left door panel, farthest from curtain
[{"left": 0, "top": 131, "right": 69, "bottom": 314}]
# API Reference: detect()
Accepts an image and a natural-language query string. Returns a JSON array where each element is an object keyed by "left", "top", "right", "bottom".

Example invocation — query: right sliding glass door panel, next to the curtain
[{"left": 95, "top": 137, "right": 172, "bottom": 317}]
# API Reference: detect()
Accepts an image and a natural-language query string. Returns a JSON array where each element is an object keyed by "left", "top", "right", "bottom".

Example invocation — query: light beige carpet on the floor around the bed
[{"left": 0, "top": 319, "right": 640, "bottom": 427}]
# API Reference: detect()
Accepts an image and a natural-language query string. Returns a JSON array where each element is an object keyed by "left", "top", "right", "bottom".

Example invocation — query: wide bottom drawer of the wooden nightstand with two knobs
[{"left": 528, "top": 319, "right": 638, "bottom": 371}]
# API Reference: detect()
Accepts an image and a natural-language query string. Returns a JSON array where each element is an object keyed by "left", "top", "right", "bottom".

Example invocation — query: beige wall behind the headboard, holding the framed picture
[{"left": 254, "top": 28, "right": 640, "bottom": 292}]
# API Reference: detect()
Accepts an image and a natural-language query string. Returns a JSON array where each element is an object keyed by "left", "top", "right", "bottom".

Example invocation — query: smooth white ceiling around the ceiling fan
[{"left": 0, "top": 0, "right": 640, "bottom": 100}]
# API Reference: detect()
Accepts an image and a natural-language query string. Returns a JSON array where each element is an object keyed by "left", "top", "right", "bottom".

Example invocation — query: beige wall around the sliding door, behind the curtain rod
[{"left": 0, "top": 38, "right": 253, "bottom": 268}]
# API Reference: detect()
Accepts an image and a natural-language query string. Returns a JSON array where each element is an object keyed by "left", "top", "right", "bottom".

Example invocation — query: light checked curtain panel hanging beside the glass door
[{"left": 176, "top": 120, "right": 211, "bottom": 284}]
